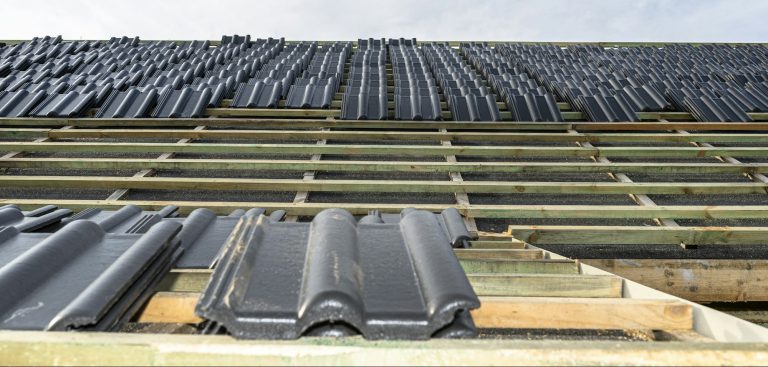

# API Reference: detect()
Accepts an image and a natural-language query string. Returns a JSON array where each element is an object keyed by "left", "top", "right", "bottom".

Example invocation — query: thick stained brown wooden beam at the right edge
[{"left": 582, "top": 259, "right": 768, "bottom": 302}]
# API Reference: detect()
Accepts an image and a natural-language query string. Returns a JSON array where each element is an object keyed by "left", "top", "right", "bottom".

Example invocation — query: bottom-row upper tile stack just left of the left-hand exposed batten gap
[{"left": 152, "top": 87, "right": 212, "bottom": 118}]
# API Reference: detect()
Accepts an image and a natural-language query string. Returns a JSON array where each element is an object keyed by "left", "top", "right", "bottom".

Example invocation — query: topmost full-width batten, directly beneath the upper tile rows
[{"left": 0, "top": 117, "right": 768, "bottom": 131}]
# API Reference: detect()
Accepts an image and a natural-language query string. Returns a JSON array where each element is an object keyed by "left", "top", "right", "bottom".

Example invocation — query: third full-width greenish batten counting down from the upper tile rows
[{"left": 0, "top": 142, "right": 768, "bottom": 158}]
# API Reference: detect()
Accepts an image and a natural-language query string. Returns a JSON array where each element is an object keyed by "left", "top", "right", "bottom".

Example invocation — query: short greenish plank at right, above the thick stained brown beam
[{"left": 507, "top": 226, "right": 768, "bottom": 245}]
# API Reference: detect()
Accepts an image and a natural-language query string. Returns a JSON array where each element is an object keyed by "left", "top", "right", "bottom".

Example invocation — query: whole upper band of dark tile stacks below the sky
[{"left": 0, "top": 35, "right": 768, "bottom": 121}]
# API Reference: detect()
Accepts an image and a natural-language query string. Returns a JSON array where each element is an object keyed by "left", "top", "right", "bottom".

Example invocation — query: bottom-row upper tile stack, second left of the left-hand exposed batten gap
[{"left": 95, "top": 88, "right": 160, "bottom": 118}]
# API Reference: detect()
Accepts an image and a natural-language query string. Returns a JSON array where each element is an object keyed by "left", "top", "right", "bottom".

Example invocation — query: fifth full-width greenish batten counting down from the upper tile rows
[{"left": 0, "top": 176, "right": 768, "bottom": 195}]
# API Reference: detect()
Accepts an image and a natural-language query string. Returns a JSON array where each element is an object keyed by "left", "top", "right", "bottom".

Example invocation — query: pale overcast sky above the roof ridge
[{"left": 0, "top": 0, "right": 768, "bottom": 42}]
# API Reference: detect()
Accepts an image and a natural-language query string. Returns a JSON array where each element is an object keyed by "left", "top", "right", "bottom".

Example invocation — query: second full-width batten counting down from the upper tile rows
[{"left": 43, "top": 129, "right": 768, "bottom": 143}]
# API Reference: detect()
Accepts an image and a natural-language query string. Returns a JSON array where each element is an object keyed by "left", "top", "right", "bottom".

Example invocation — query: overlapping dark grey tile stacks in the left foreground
[{"left": 0, "top": 205, "right": 272, "bottom": 330}]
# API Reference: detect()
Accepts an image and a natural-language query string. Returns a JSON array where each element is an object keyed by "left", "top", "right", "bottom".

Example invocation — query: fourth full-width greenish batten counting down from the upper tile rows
[{"left": 0, "top": 158, "right": 768, "bottom": 174}]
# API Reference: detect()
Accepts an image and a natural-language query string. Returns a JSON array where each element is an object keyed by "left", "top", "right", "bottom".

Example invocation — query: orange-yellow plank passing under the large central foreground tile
[{"left": 137, "top": 292, "right": 693, "bottom": 330}]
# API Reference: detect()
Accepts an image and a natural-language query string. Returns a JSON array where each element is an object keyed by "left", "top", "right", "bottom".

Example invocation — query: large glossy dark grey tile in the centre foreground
[{"left": 196, "top": 209, "right": 480, "bottom": 339}]
